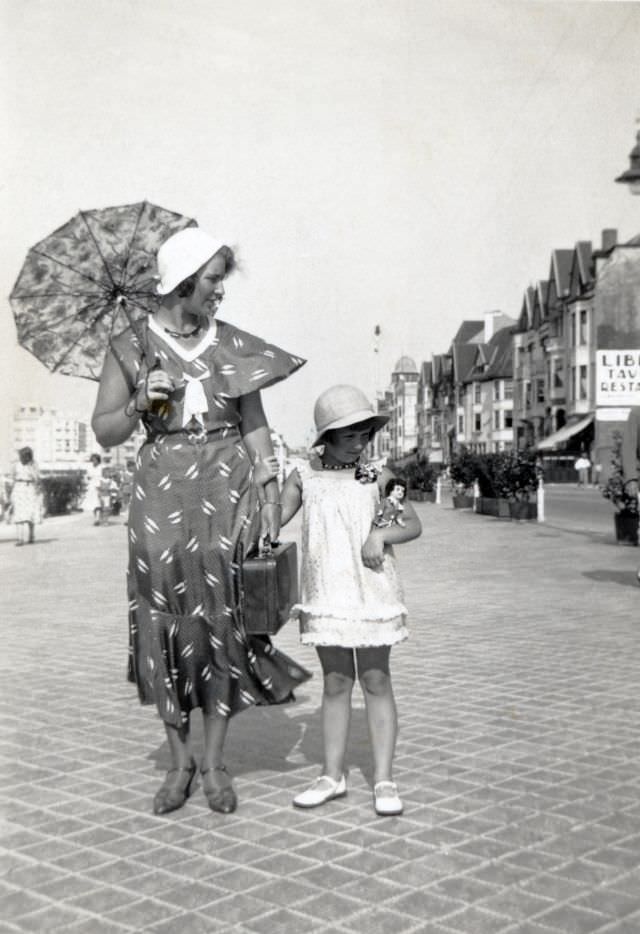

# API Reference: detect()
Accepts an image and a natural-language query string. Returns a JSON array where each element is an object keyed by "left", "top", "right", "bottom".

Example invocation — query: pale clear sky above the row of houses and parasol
[{"left": 0, "top": 0, "right": 640, "bottom": 467}]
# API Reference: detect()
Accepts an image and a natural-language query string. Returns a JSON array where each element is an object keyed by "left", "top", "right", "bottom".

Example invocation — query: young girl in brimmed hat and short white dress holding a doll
[{"left": 254, "top": 385, "right": 422, "bottom": 815}]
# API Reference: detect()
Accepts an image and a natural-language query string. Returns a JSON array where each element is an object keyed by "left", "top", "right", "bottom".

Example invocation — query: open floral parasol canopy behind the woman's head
[{"left": 9, "top": 201, "right": 197, "bottom": 380}]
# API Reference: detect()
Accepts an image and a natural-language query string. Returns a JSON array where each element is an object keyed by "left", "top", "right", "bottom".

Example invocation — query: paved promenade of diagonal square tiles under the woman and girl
[{"left": 0, "top": 490, "right": 640, "bottom": 934}]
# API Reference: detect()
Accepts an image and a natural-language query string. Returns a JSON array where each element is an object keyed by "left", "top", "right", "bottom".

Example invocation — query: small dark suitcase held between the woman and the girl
[{"left": 239, "top": 542, "right": 298, "bottom": 636}]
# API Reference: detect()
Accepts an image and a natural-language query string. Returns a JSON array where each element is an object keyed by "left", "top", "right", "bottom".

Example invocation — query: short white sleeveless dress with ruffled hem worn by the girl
[{"left": 292, "top": 458, "right": 408, "bottom": 648}]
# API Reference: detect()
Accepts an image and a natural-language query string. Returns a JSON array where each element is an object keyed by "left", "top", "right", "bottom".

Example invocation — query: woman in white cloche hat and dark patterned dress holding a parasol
[{"left": 92, "top": 228, "right": 310, "bottom": 814}]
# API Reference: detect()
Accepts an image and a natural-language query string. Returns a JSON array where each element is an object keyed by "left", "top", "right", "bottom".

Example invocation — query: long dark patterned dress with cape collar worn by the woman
[{"left": 111, "top": 318, "right": 310, "bottom": 727}]
